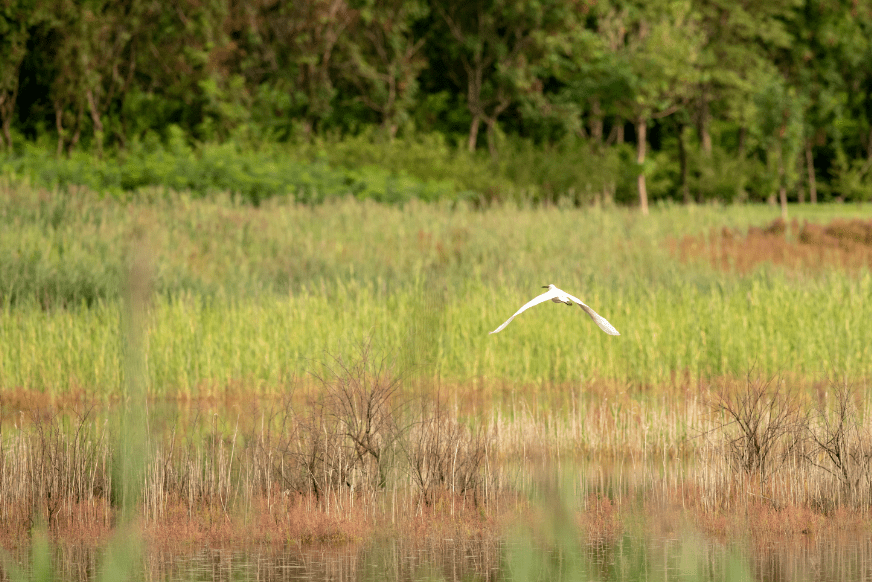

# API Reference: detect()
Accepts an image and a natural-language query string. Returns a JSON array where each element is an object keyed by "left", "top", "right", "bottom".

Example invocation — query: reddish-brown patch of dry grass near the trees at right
[{"left": 667, "top": 218, "right": 872, "bottom": 274}]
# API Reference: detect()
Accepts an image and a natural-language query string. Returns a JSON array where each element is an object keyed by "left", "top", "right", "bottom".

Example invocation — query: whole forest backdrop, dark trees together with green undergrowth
[{"left": 0, "top": 0, "right": 872, "bottom": 212}]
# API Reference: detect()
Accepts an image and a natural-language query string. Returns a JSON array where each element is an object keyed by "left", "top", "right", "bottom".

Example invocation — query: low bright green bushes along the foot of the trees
[{"left": 0, "top": 126, "right": 656, "bottom": 205}]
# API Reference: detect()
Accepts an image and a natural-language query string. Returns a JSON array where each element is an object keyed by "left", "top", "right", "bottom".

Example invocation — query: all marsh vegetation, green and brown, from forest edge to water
[{"left": 0, "top": 183, "right": 872, "bottom": 578}]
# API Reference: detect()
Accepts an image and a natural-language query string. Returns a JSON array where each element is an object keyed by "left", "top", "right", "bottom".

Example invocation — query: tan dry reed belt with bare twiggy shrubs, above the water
[{"left": 0, "top": 364, "right": 872, "bottom": 542}]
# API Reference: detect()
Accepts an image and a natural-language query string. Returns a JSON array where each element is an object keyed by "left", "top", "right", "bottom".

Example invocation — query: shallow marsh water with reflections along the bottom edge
[{"left": 6, "top": 531, "right": 872, "bottom": 582}]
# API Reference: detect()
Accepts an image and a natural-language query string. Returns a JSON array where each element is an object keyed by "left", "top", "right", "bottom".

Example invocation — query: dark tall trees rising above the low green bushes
[{"left": 0, "top": 0, "right": 872, "bottom": 211}]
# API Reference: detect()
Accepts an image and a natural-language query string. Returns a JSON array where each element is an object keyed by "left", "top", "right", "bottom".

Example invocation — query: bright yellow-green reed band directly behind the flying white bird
[{"left": 0, "top": 258, "right": 872, "bottom": 397}]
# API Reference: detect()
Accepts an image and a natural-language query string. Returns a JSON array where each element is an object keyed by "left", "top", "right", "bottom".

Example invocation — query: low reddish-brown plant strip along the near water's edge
[{"left": 6, "top": 483, "right": 872, "bottom": 555}]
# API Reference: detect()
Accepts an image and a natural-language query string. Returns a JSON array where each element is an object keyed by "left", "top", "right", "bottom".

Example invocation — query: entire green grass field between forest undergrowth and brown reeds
[{"left": 0, "top": 183, "right": 872, "bottom": 394}]
